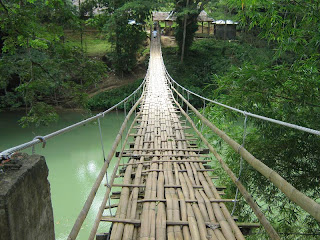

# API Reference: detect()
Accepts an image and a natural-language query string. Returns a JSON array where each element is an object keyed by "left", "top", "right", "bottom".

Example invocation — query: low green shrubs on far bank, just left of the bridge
[{"left": 88, "top": 79, "right": 142, "bottom": 110}]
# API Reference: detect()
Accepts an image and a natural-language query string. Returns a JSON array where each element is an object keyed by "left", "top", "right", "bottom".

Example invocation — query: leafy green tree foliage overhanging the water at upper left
[{"left": 0, "top": 0, "right": 107, "bottom": 126}]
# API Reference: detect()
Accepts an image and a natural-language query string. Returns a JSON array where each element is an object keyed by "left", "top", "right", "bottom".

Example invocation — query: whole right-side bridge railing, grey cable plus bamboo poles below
[{"left": 163, "top": 56, "right": 320, "bottom": 232}]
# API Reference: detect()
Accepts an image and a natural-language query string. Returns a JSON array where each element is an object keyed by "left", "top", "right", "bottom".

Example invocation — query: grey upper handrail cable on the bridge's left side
[{"left": 0, "top": 78, "right": 148, "bottom": 159}]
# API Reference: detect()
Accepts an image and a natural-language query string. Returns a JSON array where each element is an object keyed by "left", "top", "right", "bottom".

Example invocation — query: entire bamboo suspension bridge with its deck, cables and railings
[{"left": 1, "top": 34, "right": 320, "bottom": 240}]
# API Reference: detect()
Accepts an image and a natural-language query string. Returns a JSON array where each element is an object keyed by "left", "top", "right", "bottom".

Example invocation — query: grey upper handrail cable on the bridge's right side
[{"left": 164, "top": 68, "right": 320, "bottom": 136}]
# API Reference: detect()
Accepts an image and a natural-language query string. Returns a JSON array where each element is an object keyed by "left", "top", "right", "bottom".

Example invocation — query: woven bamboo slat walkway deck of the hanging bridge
[{"left": 101, "top": 39, "right": 254, "bottom": 240}]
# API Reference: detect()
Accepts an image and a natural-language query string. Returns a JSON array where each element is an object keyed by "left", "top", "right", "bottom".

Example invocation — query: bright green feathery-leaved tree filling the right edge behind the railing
[{"left": 211, "top": 0, "right": 320, "bottom": 236}]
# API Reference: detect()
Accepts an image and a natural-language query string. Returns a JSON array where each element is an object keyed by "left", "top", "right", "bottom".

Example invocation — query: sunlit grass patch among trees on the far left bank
[{"left": 65, "top": 31, "right": 111, "bottom": 57}]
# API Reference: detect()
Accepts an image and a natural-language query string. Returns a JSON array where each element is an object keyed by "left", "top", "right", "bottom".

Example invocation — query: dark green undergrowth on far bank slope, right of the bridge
[{"left": 163, "top": 39, "right": 272, "bottom": 107}]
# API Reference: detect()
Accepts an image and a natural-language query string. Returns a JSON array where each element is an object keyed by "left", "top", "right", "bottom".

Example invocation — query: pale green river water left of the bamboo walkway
[{"left": 0, "top": 112, "right": 132, "bottom": 240}]
